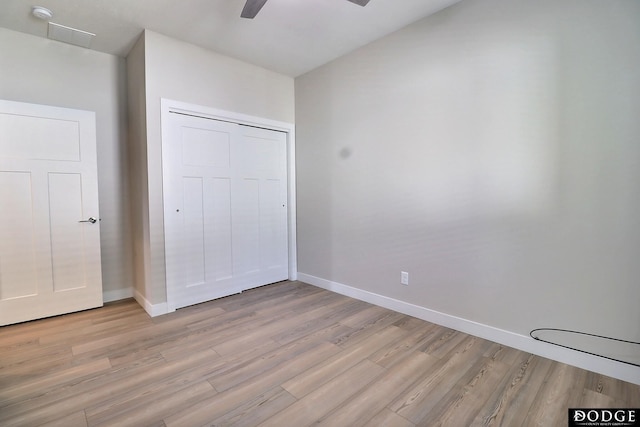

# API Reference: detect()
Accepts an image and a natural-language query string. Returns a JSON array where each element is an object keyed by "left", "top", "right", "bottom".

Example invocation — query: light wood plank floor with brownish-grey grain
[{"left": 0, "top": 282, "right": 640, "bottom": 427}]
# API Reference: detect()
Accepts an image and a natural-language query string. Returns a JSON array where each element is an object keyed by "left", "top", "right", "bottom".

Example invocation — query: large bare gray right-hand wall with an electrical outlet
[{"left": 295, "top": 0, "right": 640, "bottom": 352}]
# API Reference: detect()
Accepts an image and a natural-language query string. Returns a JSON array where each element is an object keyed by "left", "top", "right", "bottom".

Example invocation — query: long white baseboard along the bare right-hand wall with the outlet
[{"left": 298, "top": 272, "right": 640, "bottom": 385}]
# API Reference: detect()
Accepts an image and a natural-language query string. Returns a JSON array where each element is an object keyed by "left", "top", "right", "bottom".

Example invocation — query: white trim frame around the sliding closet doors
[{"left": 160, "top": 98, "right": 298, "bottom": 313}]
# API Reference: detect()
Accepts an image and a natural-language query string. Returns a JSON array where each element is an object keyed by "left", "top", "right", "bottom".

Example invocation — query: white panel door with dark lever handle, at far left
[{"left": 0, "top": 101, "right": 102, "bottom": 325}]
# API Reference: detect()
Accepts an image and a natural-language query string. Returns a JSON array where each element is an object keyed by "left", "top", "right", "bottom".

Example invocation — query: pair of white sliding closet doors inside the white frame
[{"left": 163, "top": 113, "right": 288, "bottom": 309}]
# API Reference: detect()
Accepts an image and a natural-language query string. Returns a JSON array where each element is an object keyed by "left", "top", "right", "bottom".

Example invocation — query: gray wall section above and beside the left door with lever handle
[{"left": 0, "top": 28, "right": 133, "bottom": 299}]
